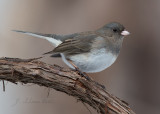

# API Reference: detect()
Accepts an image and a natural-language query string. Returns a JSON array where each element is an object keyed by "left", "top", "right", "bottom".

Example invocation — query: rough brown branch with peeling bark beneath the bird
[{"left": 0, "top": 58, "right": 135, "bottom": 114}]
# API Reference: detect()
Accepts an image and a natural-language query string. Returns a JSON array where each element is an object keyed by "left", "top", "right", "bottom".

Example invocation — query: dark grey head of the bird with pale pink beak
[{"left": 97, "top": 22, "right": 129, "bottom": 38}]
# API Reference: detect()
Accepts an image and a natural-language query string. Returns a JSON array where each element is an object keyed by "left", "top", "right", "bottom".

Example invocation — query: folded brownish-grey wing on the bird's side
[{"left": 45, "top": 34, "right": 97, "bottom": 56}]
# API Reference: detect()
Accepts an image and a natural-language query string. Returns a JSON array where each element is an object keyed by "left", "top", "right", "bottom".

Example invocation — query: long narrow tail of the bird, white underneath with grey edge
[{"left": 12, "top": 30, "right": 62, "bottom": 47}]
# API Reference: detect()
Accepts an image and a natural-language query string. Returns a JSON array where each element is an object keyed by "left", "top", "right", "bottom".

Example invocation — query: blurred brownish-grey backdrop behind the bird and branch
[{"left": 0, "top": 0, "right": 160, "bottom": 114}]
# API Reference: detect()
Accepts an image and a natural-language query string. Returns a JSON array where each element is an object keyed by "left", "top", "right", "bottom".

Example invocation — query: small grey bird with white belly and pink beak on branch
[{"left": 15, "top": 22, "right": 129, "bottom": 73}]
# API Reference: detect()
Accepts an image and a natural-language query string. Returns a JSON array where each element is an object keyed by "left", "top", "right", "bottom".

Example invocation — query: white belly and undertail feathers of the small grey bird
[{"left": 62, "top": 49, "right": 117, "bottom": 73}]
